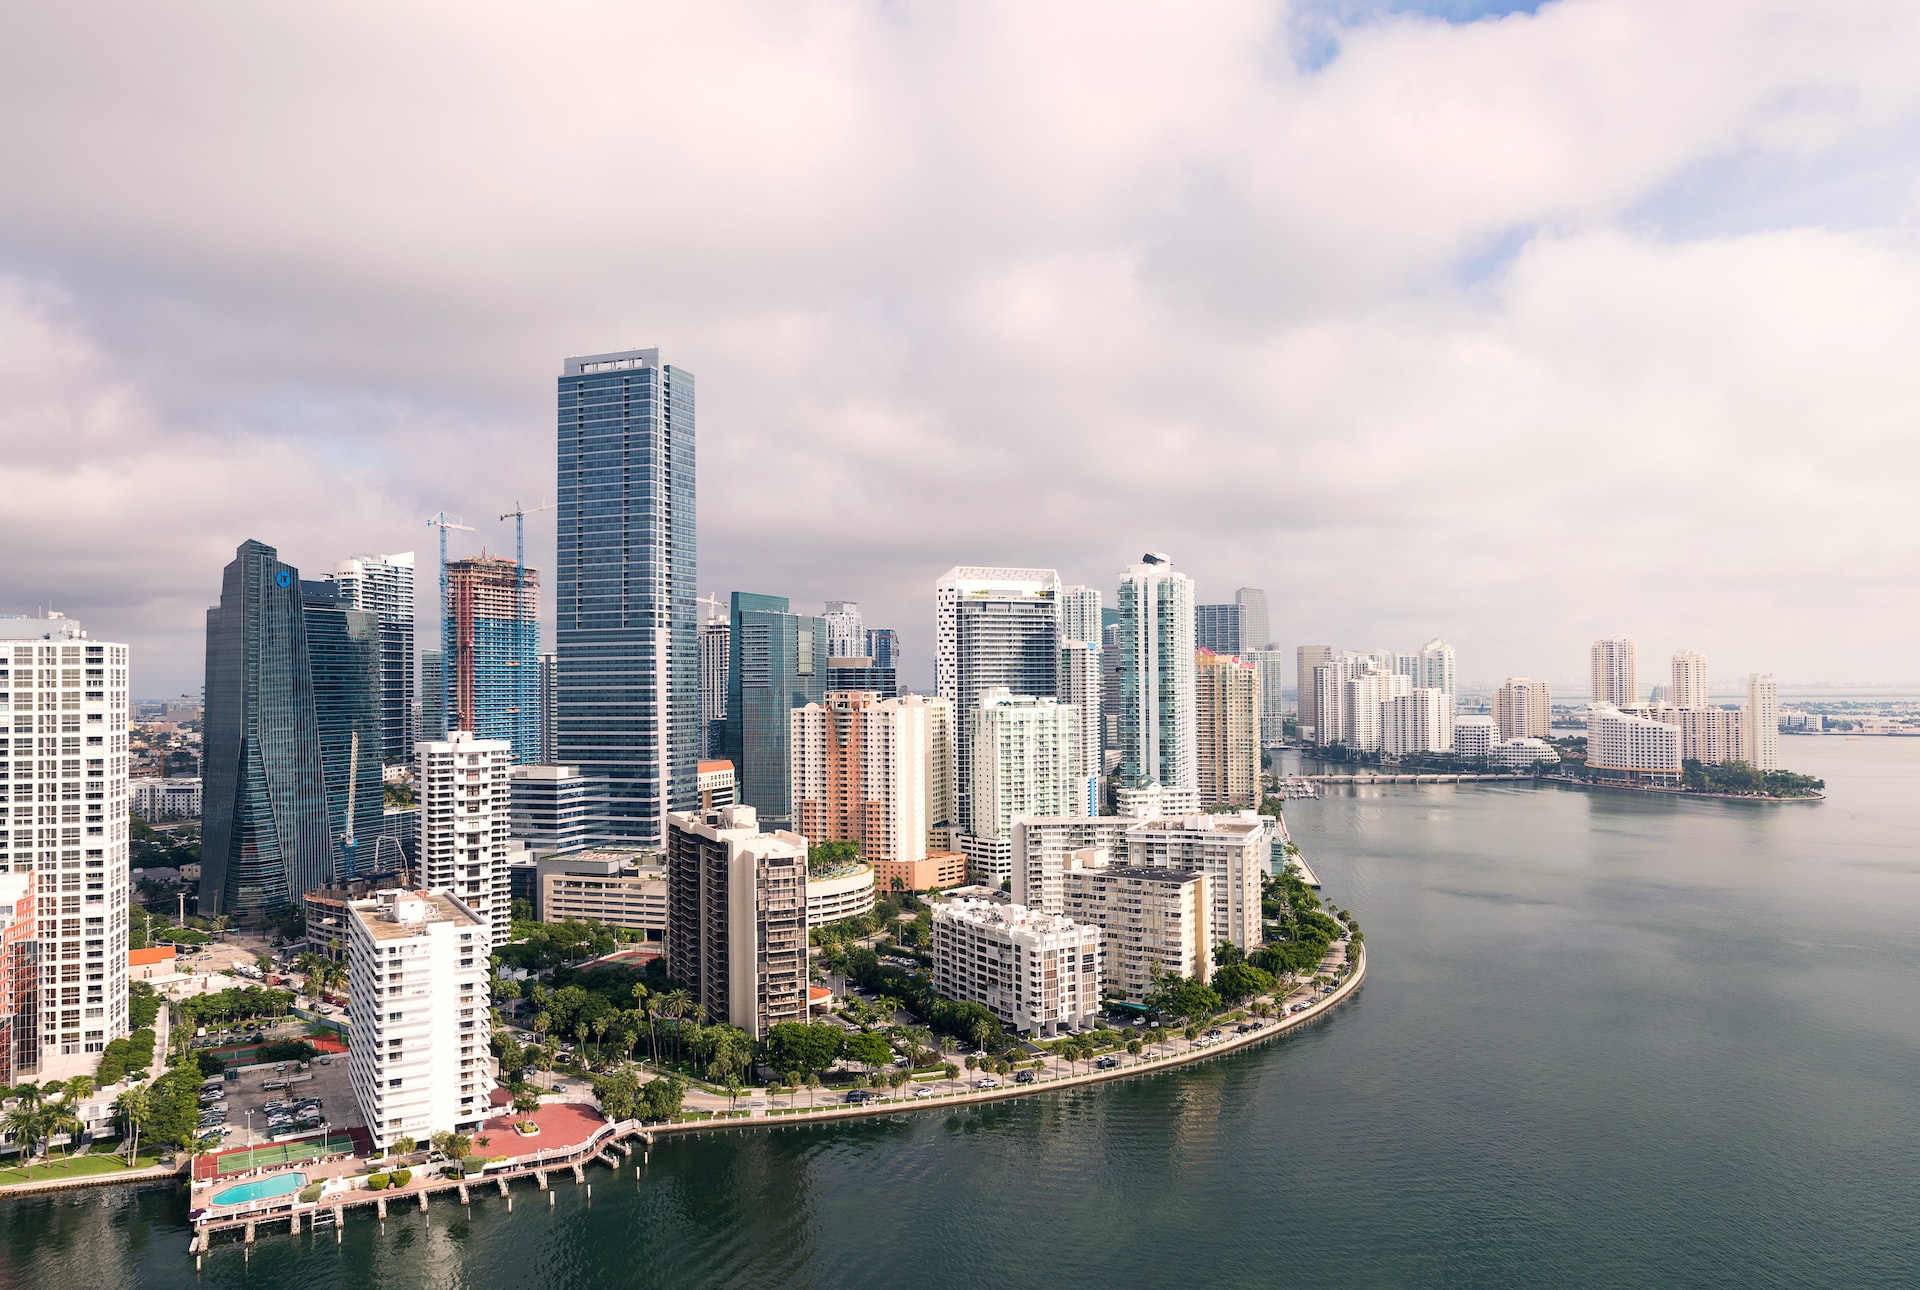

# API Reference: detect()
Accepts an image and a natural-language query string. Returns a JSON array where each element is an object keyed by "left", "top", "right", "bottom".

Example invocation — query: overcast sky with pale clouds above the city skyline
[{"left": 0, "top": 0, "right": 1920, "bottom": 697}]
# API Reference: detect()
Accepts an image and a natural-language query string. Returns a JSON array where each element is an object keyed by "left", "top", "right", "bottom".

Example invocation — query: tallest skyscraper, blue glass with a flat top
[{"left": 555, "top": 349, "right": 701, "bottom": 845}]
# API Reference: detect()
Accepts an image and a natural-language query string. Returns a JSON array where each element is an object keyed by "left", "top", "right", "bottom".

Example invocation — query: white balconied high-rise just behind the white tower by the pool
[{"left": 417, "top": 729, "right": 513, "bottom": 952}]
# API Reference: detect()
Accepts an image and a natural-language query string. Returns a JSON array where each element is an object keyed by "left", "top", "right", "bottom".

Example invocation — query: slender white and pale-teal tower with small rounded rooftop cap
[{"left": 1119, "top": 551, "right": 1200, "bottom": 789}]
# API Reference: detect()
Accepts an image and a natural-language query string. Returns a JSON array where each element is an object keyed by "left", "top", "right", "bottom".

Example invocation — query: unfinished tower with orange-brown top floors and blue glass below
[{"left": 442, "top": 555, "right": 540, "bottom": 764}]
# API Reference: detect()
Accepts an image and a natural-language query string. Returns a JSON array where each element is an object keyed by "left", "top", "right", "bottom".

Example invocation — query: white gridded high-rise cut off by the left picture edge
[{"left": 0, "top": 614, "right": 131, "bottom": 1081}]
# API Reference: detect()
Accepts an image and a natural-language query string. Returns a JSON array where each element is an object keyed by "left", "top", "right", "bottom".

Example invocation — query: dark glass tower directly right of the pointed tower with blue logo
[{"left": 300, "top": 582, "right": 389, "bottom": 877}]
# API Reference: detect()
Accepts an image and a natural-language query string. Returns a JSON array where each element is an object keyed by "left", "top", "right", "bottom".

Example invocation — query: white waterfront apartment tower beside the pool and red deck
[{"left": 348, "top": 886, "right": 505, "bottom": 1150}]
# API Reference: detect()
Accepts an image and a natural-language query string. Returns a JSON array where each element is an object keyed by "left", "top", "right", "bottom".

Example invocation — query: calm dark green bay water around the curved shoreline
[{"left": 0, "top": 739, "right": 1920, "bottom": 1288}]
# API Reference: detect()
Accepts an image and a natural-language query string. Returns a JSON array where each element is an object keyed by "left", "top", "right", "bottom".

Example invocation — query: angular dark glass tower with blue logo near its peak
[{"left": 200, "top": 539, "right": 334, "bottom": 918}]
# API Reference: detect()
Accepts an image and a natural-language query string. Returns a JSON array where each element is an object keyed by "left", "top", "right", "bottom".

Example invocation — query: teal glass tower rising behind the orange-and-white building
[{"left": 726, "top": 591, "right": 828, "bottom": 829}]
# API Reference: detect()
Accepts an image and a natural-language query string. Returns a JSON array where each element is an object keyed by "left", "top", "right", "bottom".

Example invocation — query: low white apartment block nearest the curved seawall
[{"left": 933, "top": 900, "right": 1106, "bottom": 1035}]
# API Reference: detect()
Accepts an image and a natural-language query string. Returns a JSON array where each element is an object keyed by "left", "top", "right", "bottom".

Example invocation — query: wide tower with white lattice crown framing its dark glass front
[{"left": 933, "top": 564, "right": 1060, "bottom": 833}]
